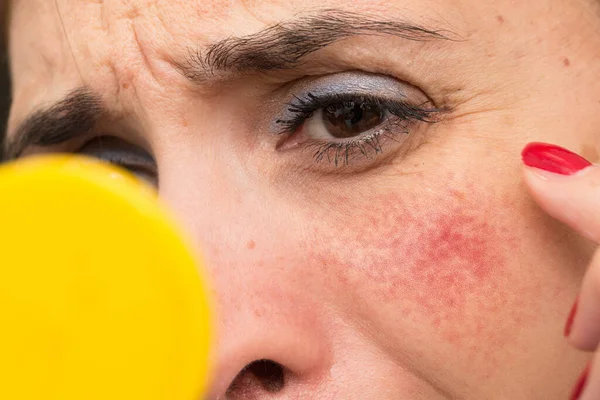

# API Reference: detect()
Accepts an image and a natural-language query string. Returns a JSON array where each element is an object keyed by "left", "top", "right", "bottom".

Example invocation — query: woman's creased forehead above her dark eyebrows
[{"left": 5, "top": 0, "right": 458, "bottom": 124}]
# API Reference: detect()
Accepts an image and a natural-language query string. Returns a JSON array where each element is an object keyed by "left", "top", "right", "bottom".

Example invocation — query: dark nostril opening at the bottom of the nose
[{"left": 227, "top": 360, "right": 285, "bottom": 397}]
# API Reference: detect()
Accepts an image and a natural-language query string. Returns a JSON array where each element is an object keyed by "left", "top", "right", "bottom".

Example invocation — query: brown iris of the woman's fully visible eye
[{"left": 323, "top": 101, "right": 385, "bottom": 139}]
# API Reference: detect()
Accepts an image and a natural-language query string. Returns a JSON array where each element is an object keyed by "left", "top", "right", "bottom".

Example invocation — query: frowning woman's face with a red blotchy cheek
[{"left": 7, "top": 0, "right": 600, "bottom": 400}]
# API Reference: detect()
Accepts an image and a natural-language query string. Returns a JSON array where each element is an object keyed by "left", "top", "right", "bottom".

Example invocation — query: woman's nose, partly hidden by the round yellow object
[{"left": 159, "top": 157, "right": 330, "bottom": 399}]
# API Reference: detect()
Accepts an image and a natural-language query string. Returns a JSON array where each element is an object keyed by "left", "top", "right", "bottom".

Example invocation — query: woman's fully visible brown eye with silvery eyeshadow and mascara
[{"left": 276, "top": 73, "right": 441, "bottom": 166}]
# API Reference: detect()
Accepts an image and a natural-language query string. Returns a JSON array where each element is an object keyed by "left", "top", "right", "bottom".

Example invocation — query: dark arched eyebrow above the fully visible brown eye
[{"left": 178, "top": 10, "right": 453, "bottom": 83}]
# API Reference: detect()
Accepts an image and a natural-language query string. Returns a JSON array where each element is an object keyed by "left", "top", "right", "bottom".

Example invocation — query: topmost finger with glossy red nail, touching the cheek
[{"left": 522, "top": 143, "right": 600, "bottom": 243}]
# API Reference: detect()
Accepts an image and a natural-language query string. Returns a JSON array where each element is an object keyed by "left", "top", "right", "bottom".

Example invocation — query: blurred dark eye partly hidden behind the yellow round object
[{"left": 78, "top": 136, "right": 158, "bottom": 188}]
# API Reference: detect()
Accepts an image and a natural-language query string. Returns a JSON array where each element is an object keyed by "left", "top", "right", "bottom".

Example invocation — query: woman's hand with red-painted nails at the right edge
[{"left": 522, "top": 143, "right": 600, "bottom": 400}]
